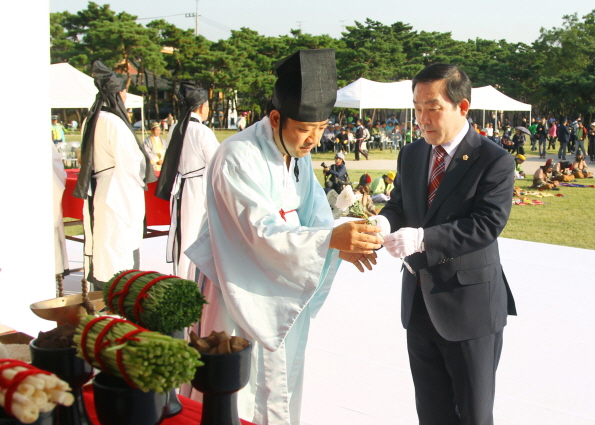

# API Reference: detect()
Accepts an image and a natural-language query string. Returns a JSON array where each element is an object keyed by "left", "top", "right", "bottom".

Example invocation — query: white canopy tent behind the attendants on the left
[{"left": 50, "top": 63, "right": 145, "bottom": 138}]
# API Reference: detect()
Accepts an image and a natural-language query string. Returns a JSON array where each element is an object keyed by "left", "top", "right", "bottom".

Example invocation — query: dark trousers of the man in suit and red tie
[{"left": 407, "top": 289, "right": 502, "bottom": 425}]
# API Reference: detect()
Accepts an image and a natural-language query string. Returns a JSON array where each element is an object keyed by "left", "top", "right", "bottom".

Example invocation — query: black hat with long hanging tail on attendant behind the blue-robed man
[{"left": 155, "top": 81, "right": 209, "bottom": 201}]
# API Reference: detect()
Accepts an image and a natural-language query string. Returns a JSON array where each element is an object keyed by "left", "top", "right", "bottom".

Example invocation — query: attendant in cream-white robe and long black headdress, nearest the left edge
[{"left": 74, "top": 61, "right": 156, "bottom": 290}]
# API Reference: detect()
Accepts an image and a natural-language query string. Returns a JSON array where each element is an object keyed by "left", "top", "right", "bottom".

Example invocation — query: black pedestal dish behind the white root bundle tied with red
[{"left": 29, "top": 339, "right": 93, "bottom": 425}]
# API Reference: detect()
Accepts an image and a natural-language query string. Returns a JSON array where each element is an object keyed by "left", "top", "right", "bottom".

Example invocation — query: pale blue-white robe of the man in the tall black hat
[{"left": 186, "top": 118, "right": 339, "bottom": 425}]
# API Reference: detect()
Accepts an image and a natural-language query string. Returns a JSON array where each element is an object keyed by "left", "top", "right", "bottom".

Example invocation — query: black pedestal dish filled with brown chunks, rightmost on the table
[{"left": 192, "top": 342, "right": 252, "bottom": 425}]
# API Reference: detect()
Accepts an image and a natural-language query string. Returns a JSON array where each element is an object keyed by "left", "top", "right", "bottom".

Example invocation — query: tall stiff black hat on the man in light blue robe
[{"left": 273, "top": 49, "right": 337, "bottom": 122}]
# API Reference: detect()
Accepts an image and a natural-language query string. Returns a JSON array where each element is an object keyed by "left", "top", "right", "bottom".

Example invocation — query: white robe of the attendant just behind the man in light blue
[{"left": 167, "top": 112, "right": 219, "bottom": 280}]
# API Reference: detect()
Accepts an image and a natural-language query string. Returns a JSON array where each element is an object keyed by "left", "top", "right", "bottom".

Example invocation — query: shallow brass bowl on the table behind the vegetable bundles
[{"left": 30, "top": 291, "right": 105, "bottom": 326}]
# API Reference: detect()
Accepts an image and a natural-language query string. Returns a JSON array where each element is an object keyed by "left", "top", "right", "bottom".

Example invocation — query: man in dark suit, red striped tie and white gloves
[{"left": 379, "top": 64, "right": 516, "bottom": 425}]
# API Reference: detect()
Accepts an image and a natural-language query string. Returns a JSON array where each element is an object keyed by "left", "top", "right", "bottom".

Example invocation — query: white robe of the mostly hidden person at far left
[{"left": 52, "top": 143, "right": 69, "bottom": 274}]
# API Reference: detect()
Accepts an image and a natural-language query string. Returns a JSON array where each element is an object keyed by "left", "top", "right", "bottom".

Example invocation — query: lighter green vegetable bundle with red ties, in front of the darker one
[{"left": 74, "top": 316, "right": 203, "bottom": 393}]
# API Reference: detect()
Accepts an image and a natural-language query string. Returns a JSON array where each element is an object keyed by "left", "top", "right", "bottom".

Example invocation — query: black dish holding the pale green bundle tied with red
[{"left": 93, "top": 372, "right": 169, "bottom": 425}]
